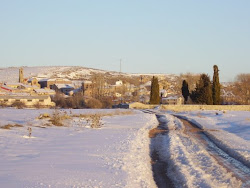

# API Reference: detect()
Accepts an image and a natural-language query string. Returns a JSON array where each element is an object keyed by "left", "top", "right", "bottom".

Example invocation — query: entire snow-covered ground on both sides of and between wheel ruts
[{"left": 0, "top": 108, "right": 250, "bottom": 188}]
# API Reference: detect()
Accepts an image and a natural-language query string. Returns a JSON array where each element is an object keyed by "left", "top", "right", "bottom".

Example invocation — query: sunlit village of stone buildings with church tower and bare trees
[{"left": 0, "top": 68, "right": 183, "bottom": 108}]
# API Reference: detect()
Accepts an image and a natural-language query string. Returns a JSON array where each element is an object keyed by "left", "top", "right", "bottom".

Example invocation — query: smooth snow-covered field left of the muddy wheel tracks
[{"left": 0, "top": 109, "right": 157, "bottom": 188}]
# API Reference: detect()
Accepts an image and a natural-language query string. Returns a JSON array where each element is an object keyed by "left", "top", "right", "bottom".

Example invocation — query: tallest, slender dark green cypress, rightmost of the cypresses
[{"left": 212, "top": 65, "right": 220, "bottom": 105}]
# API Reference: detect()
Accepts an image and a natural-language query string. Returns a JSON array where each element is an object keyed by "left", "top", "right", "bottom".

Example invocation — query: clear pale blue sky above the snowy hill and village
[{"left": 0, "top": 0, "right": 250, "bottom": 81}]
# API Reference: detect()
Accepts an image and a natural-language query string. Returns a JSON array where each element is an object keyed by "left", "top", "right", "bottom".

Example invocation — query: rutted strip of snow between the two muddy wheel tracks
[{"left": 152, "top": 114, "right": 249, "bottom": 188}]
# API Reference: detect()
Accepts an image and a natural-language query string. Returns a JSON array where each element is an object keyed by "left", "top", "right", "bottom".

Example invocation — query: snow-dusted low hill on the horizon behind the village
[{"left": 0, "top": 66, "right": 207, "bottom": 94}]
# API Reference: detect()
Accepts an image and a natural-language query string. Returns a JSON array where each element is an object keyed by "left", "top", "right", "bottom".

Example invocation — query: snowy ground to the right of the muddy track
[{"left": 175, "top": 111, "right": 250, "bottom": 167}]
